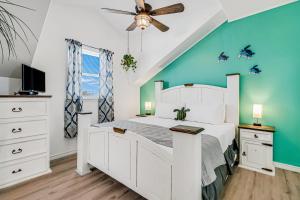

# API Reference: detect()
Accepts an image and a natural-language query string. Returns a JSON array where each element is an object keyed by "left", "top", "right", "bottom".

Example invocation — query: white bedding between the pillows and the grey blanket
[{"left": 130, "top": 116, "right": 235, "bottom": 153}]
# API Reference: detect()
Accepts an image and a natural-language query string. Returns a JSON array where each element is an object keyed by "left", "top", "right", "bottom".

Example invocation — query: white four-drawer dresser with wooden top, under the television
[{"left": 0, "top": 95, "right": 51, "bottom": 189}]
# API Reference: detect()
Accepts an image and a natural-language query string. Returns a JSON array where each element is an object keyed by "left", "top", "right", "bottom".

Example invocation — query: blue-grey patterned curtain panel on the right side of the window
[{"left": 98, "top": 49, "right": 114, "bottom": 123}]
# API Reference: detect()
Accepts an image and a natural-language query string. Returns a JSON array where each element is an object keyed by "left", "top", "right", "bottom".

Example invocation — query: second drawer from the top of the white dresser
[{"left": 0, "top": 119, "right": 48, "bottom": 140}]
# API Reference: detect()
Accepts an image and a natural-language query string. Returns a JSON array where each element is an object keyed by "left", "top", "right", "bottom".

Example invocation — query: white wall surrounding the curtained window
[{"left": 32, "top": 0, "right": 139, "bottom": 158}]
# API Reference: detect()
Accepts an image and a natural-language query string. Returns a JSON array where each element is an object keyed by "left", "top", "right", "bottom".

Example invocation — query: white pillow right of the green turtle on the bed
[{"left": 186, "top": 104, "right": 225, "bottom": 124}]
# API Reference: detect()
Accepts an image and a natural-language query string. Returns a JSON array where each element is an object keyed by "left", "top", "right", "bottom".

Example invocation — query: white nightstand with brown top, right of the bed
[{"left": 239, "top": 124, "right": 275, "bottom": 176}]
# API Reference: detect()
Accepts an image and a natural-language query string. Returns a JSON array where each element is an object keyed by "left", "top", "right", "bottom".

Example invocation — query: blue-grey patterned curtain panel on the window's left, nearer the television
[{"left": 64, "top": 40, "right": 82, "bottom": 138}]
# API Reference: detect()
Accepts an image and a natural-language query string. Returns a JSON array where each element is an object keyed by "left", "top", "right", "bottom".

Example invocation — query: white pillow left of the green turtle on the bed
[{"left": 155, "top": 102, "right": 182, "bottom": 119}]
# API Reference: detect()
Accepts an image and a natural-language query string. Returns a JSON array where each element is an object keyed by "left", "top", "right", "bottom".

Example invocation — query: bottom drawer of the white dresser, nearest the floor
[{"left": 0, "top": 156, "right": 47, "bottom": 185}]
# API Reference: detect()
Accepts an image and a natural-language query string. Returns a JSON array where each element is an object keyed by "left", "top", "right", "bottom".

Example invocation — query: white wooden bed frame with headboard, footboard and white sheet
[{"left": 77, "top": 74, "right": 239, "bottom": 200}]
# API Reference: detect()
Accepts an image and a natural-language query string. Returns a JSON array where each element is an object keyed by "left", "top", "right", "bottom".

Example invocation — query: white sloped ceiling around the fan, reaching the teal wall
[{"left": 60, "top": 0, "right": 294, "bottom": 85}]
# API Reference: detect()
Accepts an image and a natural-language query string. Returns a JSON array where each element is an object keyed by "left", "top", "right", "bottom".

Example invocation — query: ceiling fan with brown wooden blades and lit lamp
[{"left": 102, "top": 0, "right": 184, "bottom": 32}]
